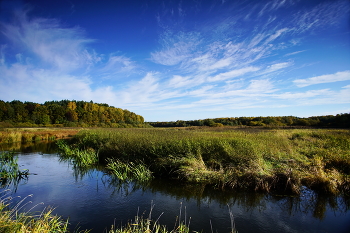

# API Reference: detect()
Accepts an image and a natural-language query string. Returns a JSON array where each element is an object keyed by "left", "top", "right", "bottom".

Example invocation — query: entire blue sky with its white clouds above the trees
[{"left": 0, "top": 0, "right": 350, "bottom": 121}]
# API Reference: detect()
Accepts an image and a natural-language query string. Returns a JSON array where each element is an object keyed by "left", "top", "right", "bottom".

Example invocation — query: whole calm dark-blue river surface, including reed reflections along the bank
[{"left": 3, "top": 141, "right": 350, "bottom": 233}]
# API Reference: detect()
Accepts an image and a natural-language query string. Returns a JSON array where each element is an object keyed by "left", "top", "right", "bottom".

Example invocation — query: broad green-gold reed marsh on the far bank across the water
[{"left": 58, "top": 128, "right": 350, "bottom": 194}]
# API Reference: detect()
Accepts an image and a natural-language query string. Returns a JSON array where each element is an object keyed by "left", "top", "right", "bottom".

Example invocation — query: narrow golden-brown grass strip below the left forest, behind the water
[{"left": 0, "top": 128, "right": 80, "bottom": 144}]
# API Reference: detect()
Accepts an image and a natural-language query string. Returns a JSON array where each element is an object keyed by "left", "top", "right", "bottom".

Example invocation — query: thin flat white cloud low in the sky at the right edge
[{"left": 293, "top": 70, "right": 350, "bottom": 87}]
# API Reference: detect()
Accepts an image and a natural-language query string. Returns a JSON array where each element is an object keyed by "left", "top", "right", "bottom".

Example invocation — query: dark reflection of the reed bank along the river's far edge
[{"left": 69, "top": 160, "right": 350, "bottom": 220}]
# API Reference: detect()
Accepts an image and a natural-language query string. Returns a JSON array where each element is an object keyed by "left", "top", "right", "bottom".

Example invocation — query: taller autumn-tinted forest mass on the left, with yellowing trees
[{"left": 0, "top": 100, "right": 145, "bottom": 127}]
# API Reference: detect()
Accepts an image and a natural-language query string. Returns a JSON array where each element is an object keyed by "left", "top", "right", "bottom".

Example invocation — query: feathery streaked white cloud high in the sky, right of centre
[{"left": 151, "top": 24, "right": 291, "bottom": 78}]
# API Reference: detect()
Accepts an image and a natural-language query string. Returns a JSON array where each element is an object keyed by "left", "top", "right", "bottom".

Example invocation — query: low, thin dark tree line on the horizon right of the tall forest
[{"left": 148, "top": 113, "right": 350, "bottom": 128}]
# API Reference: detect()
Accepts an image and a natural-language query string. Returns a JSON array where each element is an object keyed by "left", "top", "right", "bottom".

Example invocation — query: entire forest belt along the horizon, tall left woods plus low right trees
[{"left": 0, "top": 100, "right": 350, "bottom": 128}]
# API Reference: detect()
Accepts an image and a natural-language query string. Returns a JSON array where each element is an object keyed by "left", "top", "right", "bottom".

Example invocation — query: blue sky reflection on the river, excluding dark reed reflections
[{"left": 2, "top": 153, "right": 350, "bottom": 233}]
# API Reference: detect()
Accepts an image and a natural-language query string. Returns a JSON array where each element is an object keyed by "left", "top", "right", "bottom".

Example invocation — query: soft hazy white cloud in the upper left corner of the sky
[{"left": 2, "top": 12, "right": 100, "bottom": 71}]
